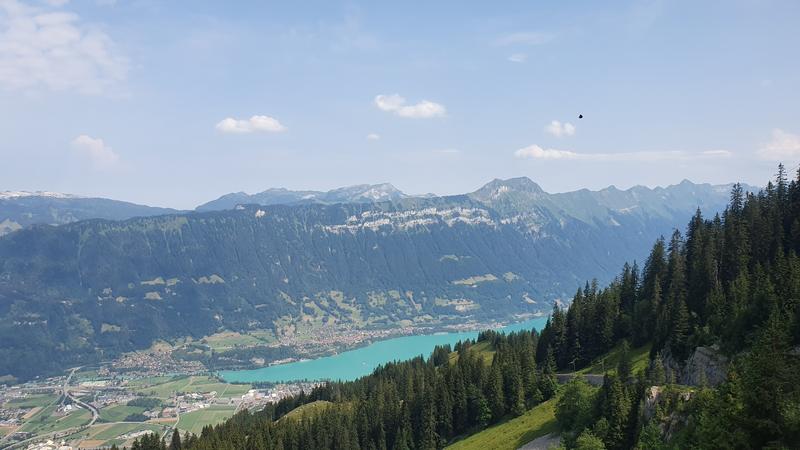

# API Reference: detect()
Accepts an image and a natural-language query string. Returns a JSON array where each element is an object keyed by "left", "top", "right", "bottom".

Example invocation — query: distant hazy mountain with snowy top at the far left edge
[{"left": 0, "top": 191, "right": 178, "bottom": 236}]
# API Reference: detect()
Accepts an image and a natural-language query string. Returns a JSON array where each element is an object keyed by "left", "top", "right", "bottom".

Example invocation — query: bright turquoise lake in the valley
[{"left": 219, "top": 316, "right": 547, "bottom": 383}]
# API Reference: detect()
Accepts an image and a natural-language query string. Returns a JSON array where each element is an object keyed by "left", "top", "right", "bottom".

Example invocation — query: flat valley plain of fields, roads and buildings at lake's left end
[{"left": 0, "top": 351, "right": 320, "bottom": 450}]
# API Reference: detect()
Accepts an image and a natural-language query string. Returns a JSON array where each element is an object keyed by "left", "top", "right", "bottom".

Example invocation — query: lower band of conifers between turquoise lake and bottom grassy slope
[{"left": 134, "top": 331, "right": 549, "bottom": 450}]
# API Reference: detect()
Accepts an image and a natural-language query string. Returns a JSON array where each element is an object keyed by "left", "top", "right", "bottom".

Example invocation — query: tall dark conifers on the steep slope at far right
[{"left": 537, "top": 166, "right": 800, "bottom": 449}]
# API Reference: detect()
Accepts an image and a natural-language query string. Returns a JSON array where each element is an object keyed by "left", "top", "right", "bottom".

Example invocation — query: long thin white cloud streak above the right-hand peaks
[{"left": 514, "top": 145, "right": 732, "bottom": 162}]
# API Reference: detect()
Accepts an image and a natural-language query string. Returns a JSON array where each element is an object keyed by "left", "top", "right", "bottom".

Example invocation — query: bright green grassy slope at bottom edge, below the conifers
[{"left": 447, "top": 399, "right": 558, "bottom": 450}]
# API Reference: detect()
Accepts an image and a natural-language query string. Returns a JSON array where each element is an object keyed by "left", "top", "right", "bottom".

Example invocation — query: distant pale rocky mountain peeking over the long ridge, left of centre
[{"left": 197, "top": 183, "right": 409, "bottom": 211}]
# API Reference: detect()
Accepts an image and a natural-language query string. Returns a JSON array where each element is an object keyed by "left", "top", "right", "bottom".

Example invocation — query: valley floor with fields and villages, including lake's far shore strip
[{"left": 0, "top": 323, "right": 544, "bottom": 450}]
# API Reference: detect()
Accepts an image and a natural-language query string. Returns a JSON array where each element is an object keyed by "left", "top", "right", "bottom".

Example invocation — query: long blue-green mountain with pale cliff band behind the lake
[{"left": 0, "top": 178, "right": 752, "bottom": 377}]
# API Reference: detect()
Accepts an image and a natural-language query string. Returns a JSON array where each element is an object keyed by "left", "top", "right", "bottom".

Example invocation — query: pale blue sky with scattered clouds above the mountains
[{"left": 0, "top": 0, "right": 800, "bottom": 208}]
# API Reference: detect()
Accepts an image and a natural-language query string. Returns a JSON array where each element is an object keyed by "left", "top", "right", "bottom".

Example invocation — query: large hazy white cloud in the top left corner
[{"left": 0, "top": 0, "right": 128, "bottom": 94}]
